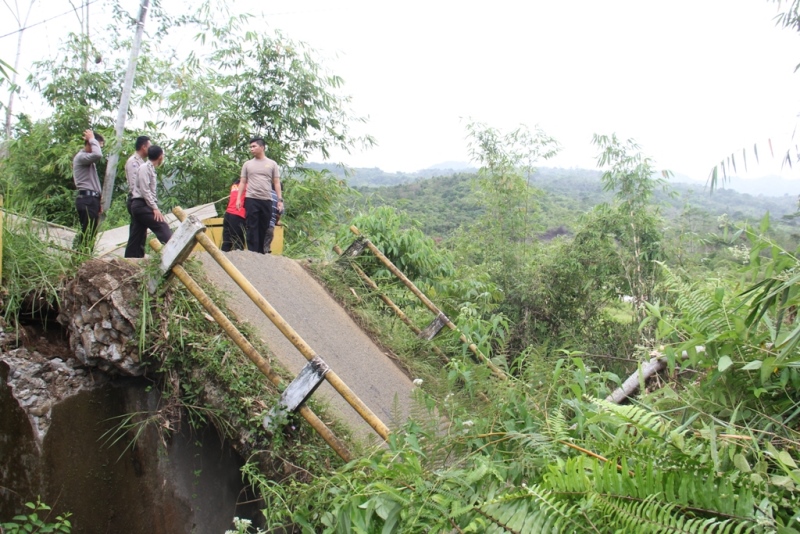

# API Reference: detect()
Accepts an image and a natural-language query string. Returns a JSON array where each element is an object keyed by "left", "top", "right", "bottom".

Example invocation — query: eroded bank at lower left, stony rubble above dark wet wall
[{"left": 0, "top": 262, "right": 258, "bottom": 534}]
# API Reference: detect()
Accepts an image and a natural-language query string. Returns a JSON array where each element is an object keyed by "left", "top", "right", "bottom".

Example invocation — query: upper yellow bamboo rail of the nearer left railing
[{"left": 172, "top": 207, "right": 389, "bottom": 440}]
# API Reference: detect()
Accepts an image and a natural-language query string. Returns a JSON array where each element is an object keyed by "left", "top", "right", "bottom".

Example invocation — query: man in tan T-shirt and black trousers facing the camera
[{"left": 236, "top": 137, "right": 283, "bottom": 254}]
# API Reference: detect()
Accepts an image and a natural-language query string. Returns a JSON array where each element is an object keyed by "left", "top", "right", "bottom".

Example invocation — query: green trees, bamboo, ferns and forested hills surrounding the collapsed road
[{"left": 0, "top": 1, "right": 800, "bottom": 534}]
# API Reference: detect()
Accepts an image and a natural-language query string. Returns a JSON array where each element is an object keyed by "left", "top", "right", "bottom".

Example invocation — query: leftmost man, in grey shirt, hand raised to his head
[{"left": 72, "top": 130, "right": 105, "bottom": 251}]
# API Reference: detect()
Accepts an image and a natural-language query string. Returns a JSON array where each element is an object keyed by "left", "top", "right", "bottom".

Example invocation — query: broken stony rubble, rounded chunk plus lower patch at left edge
[{"left": 0, "top": 259, "right": 144, "bottom": 447}]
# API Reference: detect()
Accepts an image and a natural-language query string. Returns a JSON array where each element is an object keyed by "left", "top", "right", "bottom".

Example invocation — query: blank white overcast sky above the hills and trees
[{"left": 0, "top": 0, "right": 800, "bottom": 180}]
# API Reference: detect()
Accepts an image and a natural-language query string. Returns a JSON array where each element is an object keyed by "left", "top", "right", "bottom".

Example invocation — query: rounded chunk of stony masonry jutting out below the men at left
[{"left": 58, "top": 258, "right": 144, "bottom": 376}]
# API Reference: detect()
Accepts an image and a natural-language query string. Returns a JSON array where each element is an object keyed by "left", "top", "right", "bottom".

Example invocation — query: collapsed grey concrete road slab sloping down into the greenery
[{"left": 198, "top": 251, "right": 414, "bottom": 442}]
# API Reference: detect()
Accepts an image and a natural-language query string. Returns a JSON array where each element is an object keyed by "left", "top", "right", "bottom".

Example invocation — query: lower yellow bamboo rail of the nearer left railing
[{"left": 150, "top": 239, "right": 352, "bottom": 462}]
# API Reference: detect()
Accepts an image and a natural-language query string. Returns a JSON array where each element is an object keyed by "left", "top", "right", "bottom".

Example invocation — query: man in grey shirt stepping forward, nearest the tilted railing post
[{"left": 125, "top": 145, "right": 172, "bottom": 258}]
